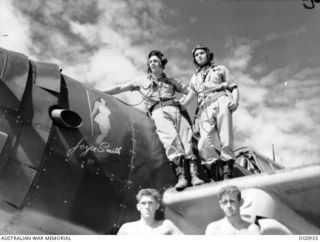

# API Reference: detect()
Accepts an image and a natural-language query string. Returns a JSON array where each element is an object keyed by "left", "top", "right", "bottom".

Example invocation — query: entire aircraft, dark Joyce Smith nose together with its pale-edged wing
[{"left": 0, "top": 48, "right": 320, "bottom": 234}]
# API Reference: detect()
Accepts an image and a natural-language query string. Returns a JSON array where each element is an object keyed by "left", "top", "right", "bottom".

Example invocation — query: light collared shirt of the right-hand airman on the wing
[{"left": 189, "top": 65, "right": 237, "bottom": 102}]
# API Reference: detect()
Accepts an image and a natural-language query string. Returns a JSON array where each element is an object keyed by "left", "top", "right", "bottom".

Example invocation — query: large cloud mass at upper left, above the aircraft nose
[{"left": 1, "top": 0, "right": 187, "bottom": 111}]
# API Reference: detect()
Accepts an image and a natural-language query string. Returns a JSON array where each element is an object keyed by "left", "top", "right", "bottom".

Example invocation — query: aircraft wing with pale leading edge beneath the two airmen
[{"left": 163, "top": 164, "right": 320, "bottom": 234}]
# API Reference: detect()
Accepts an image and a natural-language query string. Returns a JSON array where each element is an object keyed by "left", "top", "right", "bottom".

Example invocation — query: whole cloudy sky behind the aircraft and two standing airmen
[{"left": 0, "top": 0, "right": 320, "bottom": 167}]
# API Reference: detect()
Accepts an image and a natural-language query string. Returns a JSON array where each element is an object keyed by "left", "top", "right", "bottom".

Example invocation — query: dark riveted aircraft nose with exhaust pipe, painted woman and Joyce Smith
[{"left": 0, "top": 46, "right": 176, "bottom": 234}]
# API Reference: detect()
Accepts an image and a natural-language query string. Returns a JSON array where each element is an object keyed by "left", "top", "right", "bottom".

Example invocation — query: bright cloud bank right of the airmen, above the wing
[{"left": 221, "top": 35, "right": 320, "bottom": 167}]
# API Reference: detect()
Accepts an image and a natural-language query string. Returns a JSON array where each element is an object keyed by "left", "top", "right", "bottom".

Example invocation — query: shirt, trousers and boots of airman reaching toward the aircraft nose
[{"left": 133, "top": 73, "right": 204, "bottom": 191}]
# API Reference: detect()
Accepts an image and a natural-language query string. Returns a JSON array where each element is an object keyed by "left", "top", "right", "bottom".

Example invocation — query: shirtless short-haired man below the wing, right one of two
[{"left": 205, "top": 186, "right": 261, "bottom": 235}]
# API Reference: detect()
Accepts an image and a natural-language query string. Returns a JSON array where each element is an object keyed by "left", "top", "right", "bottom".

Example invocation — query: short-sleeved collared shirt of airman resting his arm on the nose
[{"left": 133, "top": 74, "right": 188, "bottom": 108}]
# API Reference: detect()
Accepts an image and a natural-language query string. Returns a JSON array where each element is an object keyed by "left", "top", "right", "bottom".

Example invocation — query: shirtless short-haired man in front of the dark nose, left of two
[{"left": 118, "top": 188, "right": 183, "bottom": 235}]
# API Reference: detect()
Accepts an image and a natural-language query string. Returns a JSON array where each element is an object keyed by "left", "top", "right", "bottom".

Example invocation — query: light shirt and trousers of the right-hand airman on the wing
[{"left": 190, "top": 65, "right": 237, "bottom": 167}]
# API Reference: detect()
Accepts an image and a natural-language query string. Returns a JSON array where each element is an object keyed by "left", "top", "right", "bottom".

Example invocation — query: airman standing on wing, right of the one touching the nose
[{"left": 180, "top": 45, "right": 239, "bottom": 180}]
